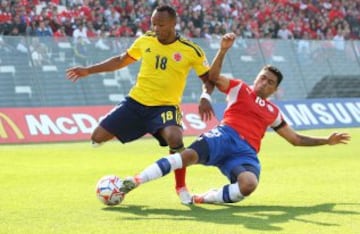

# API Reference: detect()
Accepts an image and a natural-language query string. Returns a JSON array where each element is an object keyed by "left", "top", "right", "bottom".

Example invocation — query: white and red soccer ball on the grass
[{"left": 96, "top": 175, "right": 125, "bottom": 206}]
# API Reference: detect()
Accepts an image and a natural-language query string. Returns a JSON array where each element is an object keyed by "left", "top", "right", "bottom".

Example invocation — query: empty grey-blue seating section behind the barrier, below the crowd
[{"left": 0, "top": 36, "right": 360, "bottom": 107}]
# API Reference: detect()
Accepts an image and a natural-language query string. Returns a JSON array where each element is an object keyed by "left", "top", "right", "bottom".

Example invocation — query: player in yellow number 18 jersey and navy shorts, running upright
[{"left": 66, "top": 5, "right": 214, "bottom": 203}]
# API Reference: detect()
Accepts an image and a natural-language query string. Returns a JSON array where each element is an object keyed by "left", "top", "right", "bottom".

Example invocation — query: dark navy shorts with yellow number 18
[{"left": 100, "top": 97, "right": 182, "bottom": 146}]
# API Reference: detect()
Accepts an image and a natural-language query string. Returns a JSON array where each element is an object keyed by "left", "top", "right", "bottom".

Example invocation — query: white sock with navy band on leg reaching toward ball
[{"left": 138, "top": 153, "right": 183, "bottom": 183}]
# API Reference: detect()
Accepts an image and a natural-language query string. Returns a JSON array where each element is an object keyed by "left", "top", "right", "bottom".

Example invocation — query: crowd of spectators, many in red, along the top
[{"left": 0, "top": 0, "right": 360, "bottom": 43}]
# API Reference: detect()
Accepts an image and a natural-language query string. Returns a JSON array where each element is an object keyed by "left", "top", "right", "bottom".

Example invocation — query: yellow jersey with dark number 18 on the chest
[{"left": 127, "top": 32, "right": 209, "bottom": 106}]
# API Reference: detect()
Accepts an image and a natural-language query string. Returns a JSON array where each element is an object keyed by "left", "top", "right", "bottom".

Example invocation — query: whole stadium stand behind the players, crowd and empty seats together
[{"left": 0, "top": 0, "right": 360, "bottom": 107}]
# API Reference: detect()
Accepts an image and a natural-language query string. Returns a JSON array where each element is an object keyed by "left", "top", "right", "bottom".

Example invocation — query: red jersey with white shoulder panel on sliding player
[{"left": 221, "top": 79, "right": 284, "bottom": 152}]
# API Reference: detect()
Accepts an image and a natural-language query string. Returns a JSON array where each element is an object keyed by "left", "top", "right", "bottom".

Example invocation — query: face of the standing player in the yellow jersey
[{"left": 151, "top": 10, "right": 176, "bottom": 44}]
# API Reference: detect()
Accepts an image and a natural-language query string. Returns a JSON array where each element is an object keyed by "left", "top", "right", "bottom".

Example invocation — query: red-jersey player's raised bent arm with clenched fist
[{"left": 209, "top": 33, "right": 236, "bottom": 92}]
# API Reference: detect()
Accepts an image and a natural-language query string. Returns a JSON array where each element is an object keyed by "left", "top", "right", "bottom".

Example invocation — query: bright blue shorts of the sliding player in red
[{"left": 189, "top": 126, "right": 261, "bottom": 183}]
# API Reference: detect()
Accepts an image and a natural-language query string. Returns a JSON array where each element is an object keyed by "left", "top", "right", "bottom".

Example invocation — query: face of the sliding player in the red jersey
[{"left": 254, "top": 70, "right": 278, "bottom": 99}]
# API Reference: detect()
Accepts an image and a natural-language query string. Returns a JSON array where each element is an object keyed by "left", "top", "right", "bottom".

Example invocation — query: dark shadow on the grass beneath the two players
[{"left": 104, "top": 203, "right": 360, "bottom": 231}]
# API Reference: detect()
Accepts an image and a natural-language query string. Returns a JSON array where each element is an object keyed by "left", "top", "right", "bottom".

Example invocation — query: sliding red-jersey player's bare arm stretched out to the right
[{"left": 275, "top": 124, "right": 351, "bottom": 146}]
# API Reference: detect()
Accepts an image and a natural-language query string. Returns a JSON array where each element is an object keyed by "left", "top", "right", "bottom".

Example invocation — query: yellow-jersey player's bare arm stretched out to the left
[{"left": 66, "top": 52, "right": 136, "bottom": 82}]
